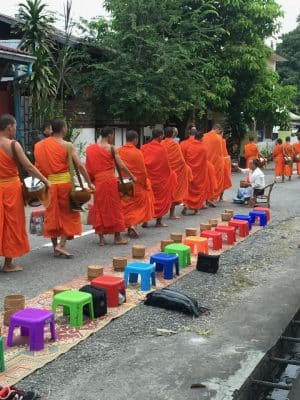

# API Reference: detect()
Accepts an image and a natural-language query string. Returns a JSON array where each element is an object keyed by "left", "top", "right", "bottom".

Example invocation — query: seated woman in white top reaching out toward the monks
[{"left": 233, "top": 160, "right": 266, "bottom": 204}]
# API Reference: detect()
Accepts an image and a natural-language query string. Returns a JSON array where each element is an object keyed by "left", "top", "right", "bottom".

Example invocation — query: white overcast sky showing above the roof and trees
[{"left": 0, "top": 0, "right": 300, "bottom": 33}]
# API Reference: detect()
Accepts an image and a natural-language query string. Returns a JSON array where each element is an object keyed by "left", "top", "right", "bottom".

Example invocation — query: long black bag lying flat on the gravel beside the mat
[{"left": 144, "top": 288, "right": 207, "bottom": 317}]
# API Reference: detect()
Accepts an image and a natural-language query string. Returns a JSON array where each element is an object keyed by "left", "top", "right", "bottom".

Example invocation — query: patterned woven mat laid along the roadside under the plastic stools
[{"left": 0, "top": 226, "right": 260, "bottom": 386}]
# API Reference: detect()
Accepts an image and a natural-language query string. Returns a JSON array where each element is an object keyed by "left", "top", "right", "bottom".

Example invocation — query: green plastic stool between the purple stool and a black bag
[{"left": 52, "top": 290, "right": 94, "bottom": 328}]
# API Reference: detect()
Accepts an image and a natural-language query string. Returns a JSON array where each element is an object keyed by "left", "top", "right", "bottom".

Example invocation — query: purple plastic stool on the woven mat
[{"left": 7, "top": 308, "right": 56, "bottom": 351}]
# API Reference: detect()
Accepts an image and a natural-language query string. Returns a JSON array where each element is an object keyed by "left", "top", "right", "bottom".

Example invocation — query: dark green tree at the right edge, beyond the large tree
[{"left": 277, "top": 16, "right": 300, "bottom": 112}]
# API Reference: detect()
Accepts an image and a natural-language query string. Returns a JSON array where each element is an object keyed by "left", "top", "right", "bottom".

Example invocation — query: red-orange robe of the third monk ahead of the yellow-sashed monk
[{"left": 141, "top": 140, "right": 177, "bottom": 218}]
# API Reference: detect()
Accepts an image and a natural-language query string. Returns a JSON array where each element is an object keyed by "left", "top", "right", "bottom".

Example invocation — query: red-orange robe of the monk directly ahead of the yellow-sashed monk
[{"left": 86, "top": 144, "right": 125, "bottom": 235}]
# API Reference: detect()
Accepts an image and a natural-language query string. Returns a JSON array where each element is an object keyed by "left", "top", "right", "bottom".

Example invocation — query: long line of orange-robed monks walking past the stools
[{"left": 0, "top": 114, "right": 231, "bottom": 272}]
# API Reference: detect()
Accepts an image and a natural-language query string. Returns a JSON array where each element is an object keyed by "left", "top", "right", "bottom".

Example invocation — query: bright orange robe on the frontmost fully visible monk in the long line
[{"left": 203, "top": 131, "right": 225, "bottom": 200}]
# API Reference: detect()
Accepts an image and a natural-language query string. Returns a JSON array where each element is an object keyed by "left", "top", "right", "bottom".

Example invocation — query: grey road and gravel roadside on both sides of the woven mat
[{"left": 0, "top": 167, "right": 300, "bottom": 400}]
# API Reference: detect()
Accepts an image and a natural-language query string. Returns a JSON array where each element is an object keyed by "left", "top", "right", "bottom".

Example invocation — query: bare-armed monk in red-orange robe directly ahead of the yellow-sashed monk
[{"left": 86, "top": 127, "right": 136, "bottom": 246}]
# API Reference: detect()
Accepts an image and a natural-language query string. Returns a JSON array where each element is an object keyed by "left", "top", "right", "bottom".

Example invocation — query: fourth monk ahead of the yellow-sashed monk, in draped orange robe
[{"left": 161, "top": 126, "right": 193, "bottom": 219}]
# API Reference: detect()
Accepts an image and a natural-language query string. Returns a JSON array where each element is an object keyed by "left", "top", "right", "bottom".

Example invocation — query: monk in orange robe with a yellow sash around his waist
[{"left": 34, "top": 119, "right": 93, "bottom": 258}]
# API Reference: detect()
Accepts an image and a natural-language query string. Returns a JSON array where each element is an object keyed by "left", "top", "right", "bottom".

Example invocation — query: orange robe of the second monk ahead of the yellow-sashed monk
[{"left": 119, "top": 143, "right": 154, "bottom": 228}]
